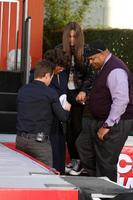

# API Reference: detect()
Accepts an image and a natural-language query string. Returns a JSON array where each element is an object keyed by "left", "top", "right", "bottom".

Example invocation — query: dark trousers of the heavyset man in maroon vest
[{"left": 76, "top": 118, "right": 133, "bottom": 182}]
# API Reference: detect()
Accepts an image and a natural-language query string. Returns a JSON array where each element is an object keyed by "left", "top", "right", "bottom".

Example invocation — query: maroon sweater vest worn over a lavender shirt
[{"left": 89, "top": 55, "right": 133, "bottom": 120}]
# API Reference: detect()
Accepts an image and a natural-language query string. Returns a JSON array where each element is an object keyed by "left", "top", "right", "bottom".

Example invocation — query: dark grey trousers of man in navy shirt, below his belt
[{"left": 16, "top": 134, "right": 53, "bottom": 167}]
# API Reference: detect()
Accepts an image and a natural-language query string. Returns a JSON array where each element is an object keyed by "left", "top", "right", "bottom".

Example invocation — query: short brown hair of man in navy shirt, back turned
[{"left": 34, "top": 60, "right": 55, "bottom": 78}]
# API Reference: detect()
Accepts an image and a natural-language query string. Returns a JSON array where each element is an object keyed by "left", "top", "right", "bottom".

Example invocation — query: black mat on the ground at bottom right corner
[{"left": 62, "top": 176, "right": 133, "bottom": 200}]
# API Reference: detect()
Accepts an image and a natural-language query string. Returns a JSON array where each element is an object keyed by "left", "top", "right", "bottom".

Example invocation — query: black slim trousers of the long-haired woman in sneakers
[{"left": 66, "top": 104, "right": 83, "bottom": 159}]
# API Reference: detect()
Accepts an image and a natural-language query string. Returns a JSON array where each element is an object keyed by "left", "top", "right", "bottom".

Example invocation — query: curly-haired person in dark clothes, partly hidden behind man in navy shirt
[{"left": 45, "top": 48, "right": 68, "bottom": 175}]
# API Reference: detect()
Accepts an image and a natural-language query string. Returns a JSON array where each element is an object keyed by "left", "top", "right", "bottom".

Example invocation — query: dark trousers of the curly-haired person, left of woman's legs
[{"left": 50, "top": 118, "right": 66, "bottom": 174}]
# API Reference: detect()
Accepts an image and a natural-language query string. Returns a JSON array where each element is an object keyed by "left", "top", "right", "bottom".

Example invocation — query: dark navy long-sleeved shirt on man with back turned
[{"left": 16, "top": 80, "right": 69, "bottom": 134}]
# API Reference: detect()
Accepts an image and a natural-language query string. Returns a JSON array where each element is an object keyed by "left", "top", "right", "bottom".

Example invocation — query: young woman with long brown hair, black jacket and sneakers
[{"left": 45, "top": 22, "right": 96, "bottom": 175}]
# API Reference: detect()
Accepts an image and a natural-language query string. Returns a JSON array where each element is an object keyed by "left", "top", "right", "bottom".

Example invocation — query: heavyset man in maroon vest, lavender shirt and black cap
[{"left": 76, "top": 40, "right": 133, "bottom": 181}]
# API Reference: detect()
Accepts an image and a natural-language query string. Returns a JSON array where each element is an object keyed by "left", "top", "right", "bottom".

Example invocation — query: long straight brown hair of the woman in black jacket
[{"left": 62, "top": 22, "right": 84, "bottom": 64}]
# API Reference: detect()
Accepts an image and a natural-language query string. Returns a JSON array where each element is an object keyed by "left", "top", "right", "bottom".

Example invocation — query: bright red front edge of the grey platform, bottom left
[{"left": 0, "top": 188, "right": 78, "bottom": 200}]
